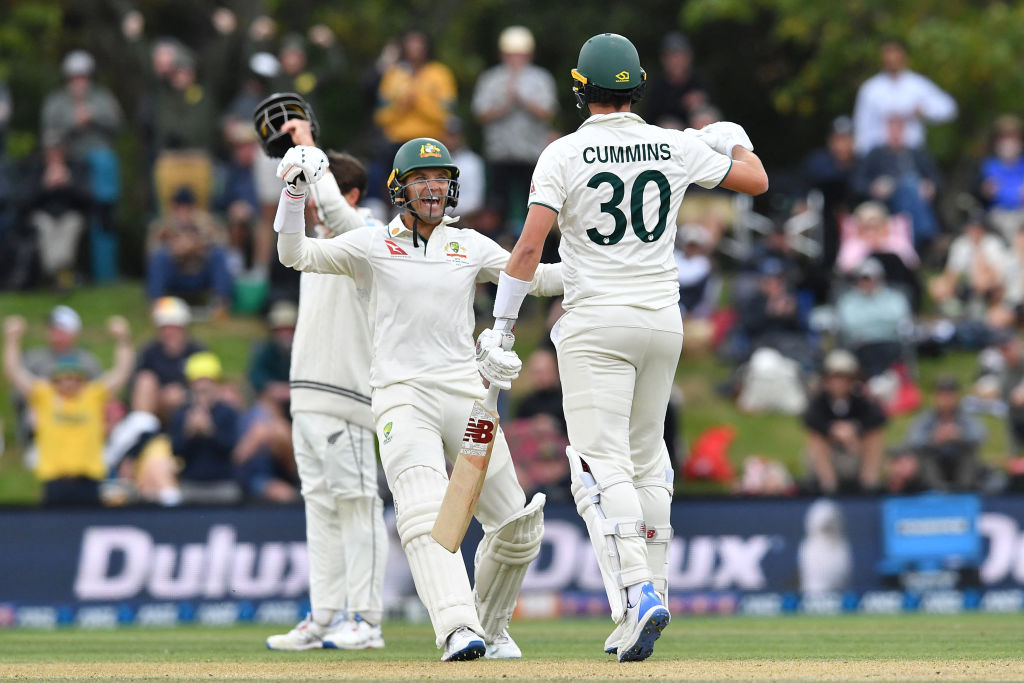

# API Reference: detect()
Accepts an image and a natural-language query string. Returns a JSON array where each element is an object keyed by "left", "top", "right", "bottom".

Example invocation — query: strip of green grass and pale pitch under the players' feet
[{"left": 0, "top": 614, "right": 1024, "bottom": 680}]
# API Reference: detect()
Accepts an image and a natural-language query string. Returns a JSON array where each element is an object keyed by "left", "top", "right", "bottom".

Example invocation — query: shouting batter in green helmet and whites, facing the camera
[{"left": 274, "top": 138, "right": 562, "bottom": 660}]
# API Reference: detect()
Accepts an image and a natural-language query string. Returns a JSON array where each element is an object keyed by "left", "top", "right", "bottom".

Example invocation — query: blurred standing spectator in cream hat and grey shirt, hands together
[{"left": 473, "top": 26, "right": 558, "bottom": 237}]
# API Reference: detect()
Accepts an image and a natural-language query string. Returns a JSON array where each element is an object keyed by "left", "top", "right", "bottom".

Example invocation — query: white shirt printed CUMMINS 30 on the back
[{"left": 529, "top": 113, "right": 732, "bottom": 310}]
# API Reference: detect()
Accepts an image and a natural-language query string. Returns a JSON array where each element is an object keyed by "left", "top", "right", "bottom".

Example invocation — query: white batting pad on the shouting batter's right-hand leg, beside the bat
[{"left": 473, "top": 494, "right": 547, "bottom": 642}]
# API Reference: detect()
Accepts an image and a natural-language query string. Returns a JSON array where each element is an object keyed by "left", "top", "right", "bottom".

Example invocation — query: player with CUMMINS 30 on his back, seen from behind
[{"left": 478, "top": 34, "right": 768, "bottom": 661}]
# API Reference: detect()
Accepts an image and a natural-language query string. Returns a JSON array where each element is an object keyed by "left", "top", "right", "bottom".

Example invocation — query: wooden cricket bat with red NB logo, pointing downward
[{"left": 430, "top": 324, "right": 512, "bottom": 553}]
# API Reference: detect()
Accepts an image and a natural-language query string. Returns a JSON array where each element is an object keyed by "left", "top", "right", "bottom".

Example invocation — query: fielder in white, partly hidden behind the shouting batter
[{"left": 266, "top": 119, "right": 387, "bottom": 650}]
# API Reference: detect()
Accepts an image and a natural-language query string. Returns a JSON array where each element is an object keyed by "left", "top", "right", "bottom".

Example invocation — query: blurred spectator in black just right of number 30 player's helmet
[{"left": 644, "top": 31, "right": 711, "bottom": 130}]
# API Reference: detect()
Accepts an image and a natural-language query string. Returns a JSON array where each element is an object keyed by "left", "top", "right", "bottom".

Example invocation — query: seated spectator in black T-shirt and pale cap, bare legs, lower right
[{"left": 804, "top": 349, "right": 887, "bottom": 495}]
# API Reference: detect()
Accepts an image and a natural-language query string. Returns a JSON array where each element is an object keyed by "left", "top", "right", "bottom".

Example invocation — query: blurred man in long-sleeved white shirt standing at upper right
[{"left": 853, "top": 40, "right": 956, "bottom": 156}]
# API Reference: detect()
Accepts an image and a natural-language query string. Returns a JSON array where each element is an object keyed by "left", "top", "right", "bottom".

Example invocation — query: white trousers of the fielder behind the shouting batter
[{"left": 292, "top": 412, "right": 387, "bottom": 624}]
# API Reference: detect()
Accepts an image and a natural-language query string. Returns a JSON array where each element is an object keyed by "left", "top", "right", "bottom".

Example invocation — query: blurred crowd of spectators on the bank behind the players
[{"left": 0, "top": 17, "right": 1024, "bottom": 505}]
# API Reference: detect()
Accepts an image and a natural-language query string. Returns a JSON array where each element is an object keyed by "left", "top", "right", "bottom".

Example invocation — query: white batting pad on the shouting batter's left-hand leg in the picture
[{"left": 391, "top": 466, "right": 483, "bottom": 654}]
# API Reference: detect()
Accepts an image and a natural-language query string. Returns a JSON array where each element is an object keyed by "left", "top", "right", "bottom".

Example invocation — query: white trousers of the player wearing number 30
[{"left": 557, "top": 305, "right": 683, "bottom": 604}]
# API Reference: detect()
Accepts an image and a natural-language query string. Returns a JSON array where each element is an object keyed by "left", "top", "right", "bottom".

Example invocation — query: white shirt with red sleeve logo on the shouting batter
[{"left": 278, "top": 197, "right": 562, "bottom": 389}]
